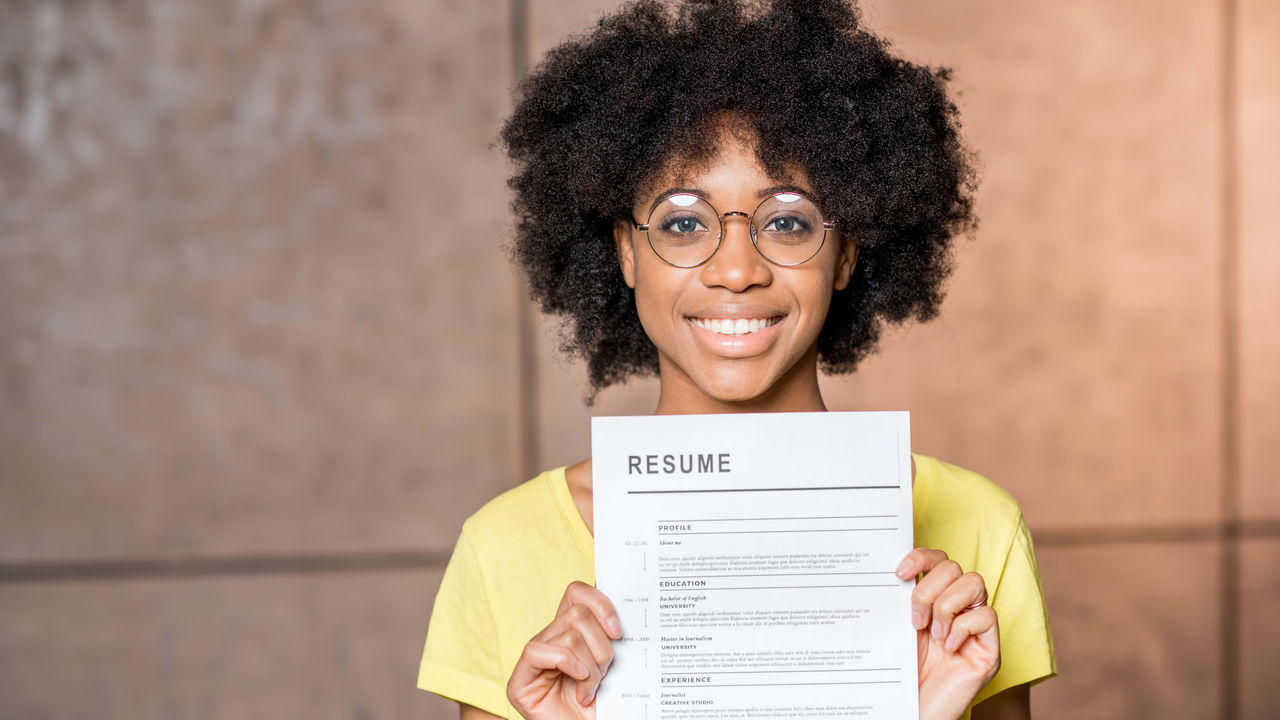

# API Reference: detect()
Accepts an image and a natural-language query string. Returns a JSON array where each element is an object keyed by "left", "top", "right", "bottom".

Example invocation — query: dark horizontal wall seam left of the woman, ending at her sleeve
[{"left": 0, "top": 551, "right": 449, "bottom": 583}]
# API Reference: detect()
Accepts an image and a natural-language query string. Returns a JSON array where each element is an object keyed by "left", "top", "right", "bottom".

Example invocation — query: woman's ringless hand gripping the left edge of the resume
[{"left": 507, "top": 582, "right": 622, "bottom": 720}]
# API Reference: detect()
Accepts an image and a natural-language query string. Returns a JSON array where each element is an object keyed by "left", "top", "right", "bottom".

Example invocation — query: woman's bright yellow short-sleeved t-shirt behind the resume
[{"left": 417, "top": 455, "right": 1057, "bottom": 719}]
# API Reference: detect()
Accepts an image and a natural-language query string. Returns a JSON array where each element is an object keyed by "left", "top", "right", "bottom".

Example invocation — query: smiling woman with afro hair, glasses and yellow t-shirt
[{"left": 419, "top": 0, "right": 1055, "bottom": 720}]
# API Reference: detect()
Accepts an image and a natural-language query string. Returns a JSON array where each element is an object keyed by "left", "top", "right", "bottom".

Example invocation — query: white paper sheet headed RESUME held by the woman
[{"left": 591, "top": 413, "right": 918, "bottom": 720}]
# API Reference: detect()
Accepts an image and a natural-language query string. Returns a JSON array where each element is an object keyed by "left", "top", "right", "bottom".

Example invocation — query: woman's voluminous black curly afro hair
[{"left": 502, "top": 0, "right": 974, "bottom": 401}]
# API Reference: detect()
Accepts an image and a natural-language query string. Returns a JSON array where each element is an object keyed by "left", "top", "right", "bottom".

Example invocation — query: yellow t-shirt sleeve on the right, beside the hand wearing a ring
[{"left": 974, "top": 514, "right": 1057, "bottom": 703}]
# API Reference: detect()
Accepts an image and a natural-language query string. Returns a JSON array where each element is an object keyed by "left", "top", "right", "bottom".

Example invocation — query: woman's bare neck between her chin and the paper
[{"left": 654, "top": 348, "right": 827, "bottom": 415}]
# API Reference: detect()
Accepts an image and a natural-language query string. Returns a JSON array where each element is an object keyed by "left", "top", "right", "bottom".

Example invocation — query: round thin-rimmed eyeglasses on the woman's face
[{"left": 631, "top": 191, "right": 836, "bottom": 268}]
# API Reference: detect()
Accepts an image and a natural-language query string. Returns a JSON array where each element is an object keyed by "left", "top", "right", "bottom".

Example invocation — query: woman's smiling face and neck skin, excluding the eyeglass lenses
[{"left": 614, "top": 131, "right": 858, "bottom": 413}]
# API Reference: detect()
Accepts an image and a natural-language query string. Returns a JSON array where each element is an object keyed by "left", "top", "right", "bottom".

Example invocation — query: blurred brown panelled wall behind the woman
[{"left": 0, "top": 0, "right": 1280, "bottom": 720}]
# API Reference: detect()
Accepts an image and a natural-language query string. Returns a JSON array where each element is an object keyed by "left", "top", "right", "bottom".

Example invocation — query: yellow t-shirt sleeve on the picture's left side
[{"left": 417, "top": 527, "right": 508, "bottom": 716}]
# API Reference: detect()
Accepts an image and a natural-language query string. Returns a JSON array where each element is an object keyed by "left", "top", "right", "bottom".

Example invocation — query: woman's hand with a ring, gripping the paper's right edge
[{"left": 897, "top": 548, "right": 1000, "bottom": 720}]
